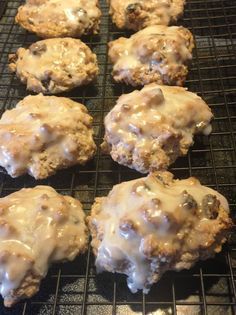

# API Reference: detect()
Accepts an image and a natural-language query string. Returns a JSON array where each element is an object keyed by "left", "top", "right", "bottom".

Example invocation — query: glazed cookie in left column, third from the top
[{"left": 0, "top": 94, "right": 96, "bottom": 179}]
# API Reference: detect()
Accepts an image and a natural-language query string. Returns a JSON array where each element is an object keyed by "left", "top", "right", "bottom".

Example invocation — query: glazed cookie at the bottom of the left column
[{"left": 0, "top": 186, "right": 88, "bottom": 306}]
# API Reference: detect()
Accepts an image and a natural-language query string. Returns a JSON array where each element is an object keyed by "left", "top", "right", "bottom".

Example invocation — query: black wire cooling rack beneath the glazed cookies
[{"left": 0, "top": 0, "right": 236, "bottom": 315}]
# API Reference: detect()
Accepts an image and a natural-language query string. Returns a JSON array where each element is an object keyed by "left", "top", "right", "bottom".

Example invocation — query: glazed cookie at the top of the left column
[{"left": 16, "top": 0, "right": 101, "bottom": 38}]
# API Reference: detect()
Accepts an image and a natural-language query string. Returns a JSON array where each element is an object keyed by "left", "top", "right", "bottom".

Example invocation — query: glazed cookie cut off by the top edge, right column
[{"left": 110, "top": 0, "right": 185, "bottom": 31}]
